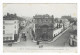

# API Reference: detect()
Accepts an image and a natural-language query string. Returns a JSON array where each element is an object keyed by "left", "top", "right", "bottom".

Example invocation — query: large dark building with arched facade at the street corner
[{"left": 34, "top": 14, "right": 54, "bottom": 41}]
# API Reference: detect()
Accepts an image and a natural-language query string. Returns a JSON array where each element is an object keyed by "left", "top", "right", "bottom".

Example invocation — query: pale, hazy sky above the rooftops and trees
[{"left": 3, "top": 3, "right": 77, "bottom": 18}]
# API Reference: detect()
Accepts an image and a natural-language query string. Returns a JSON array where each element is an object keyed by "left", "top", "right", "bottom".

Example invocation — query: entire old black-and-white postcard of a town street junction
[{"left": 3, "top": 3, "right": 77, "bottom": 52}]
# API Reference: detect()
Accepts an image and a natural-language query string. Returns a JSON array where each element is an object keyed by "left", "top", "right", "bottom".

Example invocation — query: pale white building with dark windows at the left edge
[{"left": 3, "top": 20, "right": 19, "bottom": 42}]
